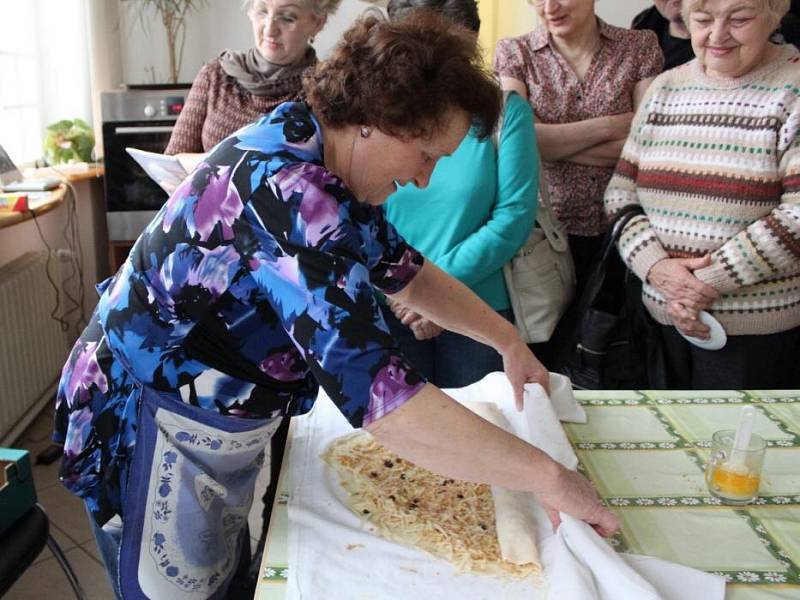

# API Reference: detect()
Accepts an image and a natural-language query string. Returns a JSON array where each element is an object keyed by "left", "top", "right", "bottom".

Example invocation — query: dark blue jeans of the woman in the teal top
[{"left": 381, "top": 306, "right": 513, "bottom": 388}]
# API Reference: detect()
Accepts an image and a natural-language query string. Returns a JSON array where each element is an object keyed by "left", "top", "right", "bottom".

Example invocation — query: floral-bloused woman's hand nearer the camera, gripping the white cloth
[{"left": 534, "top": 461, "right": 619, "bottom": 537}]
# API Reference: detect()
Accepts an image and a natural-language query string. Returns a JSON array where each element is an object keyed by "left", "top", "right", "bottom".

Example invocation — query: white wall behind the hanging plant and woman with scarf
[{"left": 117, "top": 0, "right": 382, "bottom": 83}]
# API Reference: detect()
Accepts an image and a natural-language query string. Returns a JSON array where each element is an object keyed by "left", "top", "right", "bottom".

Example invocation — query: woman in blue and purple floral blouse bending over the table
[{"left": 55, "top": 15, "right": 617, "bottom": 598}]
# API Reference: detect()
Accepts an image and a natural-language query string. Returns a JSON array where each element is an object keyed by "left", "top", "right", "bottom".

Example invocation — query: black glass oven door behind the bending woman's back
[{"left": 103, "top": 122, "right": 173, "bottom": 241}]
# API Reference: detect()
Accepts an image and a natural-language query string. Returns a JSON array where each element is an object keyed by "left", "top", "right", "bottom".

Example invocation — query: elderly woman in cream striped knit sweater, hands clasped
[{"left": 605, "top": 0, "right": 800, "bottom": 389}]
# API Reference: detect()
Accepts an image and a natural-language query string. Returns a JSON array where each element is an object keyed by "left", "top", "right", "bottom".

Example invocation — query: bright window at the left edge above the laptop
[{"left": 0, "top": 0, "right": 43, "bottom": 164}]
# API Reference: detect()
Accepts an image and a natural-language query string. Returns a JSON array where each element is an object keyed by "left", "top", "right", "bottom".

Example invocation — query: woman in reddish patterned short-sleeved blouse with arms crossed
[{"left": 495, "top": 0, "right": 664, "bottom": 293}]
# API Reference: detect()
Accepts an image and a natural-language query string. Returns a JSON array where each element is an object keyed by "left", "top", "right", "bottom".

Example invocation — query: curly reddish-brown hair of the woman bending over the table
[{"left": 303, "top": 10, "right": 502, "bottom": 138}]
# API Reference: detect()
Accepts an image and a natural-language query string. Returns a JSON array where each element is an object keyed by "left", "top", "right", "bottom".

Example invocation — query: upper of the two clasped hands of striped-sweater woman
[{"left": 647, "top": 255, "right": 719, "bottom": 314}]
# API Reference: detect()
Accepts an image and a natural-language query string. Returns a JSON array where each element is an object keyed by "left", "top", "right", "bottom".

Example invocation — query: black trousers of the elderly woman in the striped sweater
[{"left": 650, "top": 325, "right": 800, "bottom": 390}]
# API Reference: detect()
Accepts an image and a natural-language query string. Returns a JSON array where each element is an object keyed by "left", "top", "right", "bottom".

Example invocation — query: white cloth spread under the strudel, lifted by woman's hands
[{"left": 287, "top": 373, "right": 724, "bottom": 600}]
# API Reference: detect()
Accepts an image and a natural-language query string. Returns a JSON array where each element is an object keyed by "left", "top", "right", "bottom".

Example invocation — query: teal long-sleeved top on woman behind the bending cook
[{"left": 384, "top": 94, "right": 539, "bottom": 310}]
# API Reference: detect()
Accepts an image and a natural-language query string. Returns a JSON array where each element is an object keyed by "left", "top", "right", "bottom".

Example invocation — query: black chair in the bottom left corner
[{"left": 0, "top": 504, "right": 86, "bottom": 600}]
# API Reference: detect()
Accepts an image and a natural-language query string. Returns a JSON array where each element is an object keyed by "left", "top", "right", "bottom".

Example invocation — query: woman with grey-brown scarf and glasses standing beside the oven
[{"left": 165, "top": 0, "right": 341, "bottom": 154}]
